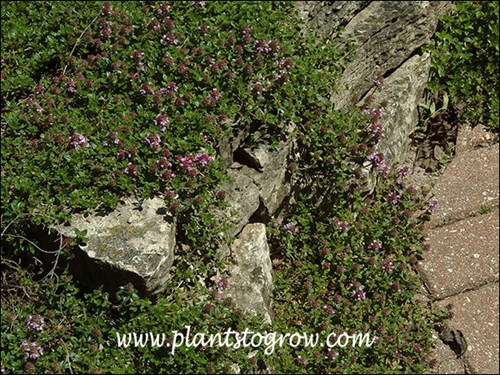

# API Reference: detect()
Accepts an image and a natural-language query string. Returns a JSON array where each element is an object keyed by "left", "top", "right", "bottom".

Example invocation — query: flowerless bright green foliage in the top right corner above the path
[{"left": 426, "top": 1, "right": 500, "bottom": 133}]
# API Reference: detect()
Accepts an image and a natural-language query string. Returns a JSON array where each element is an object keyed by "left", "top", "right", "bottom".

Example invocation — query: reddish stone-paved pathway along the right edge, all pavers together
[{"left": 418, "top": 125, "right": 500, "bottom": 374}]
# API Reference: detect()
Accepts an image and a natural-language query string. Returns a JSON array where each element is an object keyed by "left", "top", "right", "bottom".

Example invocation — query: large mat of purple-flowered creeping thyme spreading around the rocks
[{"left": 1, "top": 1, "right": 448, "bottom": 373}]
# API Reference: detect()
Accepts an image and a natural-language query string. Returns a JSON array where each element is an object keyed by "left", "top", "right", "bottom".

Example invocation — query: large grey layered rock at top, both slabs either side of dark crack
[{"left": 300, "top": 1, "right": 450, "bottom": 169}]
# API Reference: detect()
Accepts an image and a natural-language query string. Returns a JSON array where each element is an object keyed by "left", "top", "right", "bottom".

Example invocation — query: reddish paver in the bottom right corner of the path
[{"left": 436, "top": 282, "right": 500, "bottom": 374}]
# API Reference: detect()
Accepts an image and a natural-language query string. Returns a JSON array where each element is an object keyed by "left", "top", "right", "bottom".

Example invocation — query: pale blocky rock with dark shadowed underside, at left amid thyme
[{"left": 55, "top": 198, "right": 176, "bottom": 295}]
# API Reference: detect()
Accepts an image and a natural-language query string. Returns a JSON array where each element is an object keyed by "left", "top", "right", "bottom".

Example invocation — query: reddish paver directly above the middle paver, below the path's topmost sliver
[{"left": 429, "top": 143, "right": 499, "bottom": 227}]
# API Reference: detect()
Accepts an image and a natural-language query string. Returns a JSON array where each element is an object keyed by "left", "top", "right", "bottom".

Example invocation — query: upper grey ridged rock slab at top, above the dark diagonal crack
[{"left": 332, "top": 1, "right": 449, "bottom": 109}]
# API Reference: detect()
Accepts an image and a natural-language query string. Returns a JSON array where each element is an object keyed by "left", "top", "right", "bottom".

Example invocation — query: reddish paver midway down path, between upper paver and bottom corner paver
[{"left": 418, "top": 212, "right": 499, "bottom": 299}]
